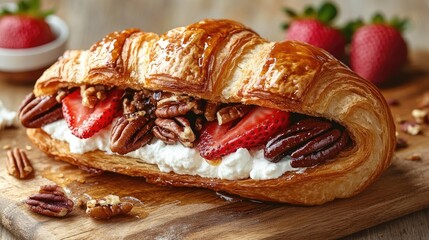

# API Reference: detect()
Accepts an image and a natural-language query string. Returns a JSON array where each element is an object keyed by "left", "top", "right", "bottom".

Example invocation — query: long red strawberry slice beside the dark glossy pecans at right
[{"left": 197, "top": 107, "right": 290, "bottom": 160}]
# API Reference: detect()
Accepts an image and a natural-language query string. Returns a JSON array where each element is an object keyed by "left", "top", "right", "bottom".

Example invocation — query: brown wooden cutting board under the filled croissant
[{"left": 0, "top": 53, "right": 429, "bottom": 239}]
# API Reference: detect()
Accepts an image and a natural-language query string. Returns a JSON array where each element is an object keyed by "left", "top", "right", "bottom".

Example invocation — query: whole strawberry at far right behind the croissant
[{"left": 350, "top": 14, "right": 408, "bottom": 86}]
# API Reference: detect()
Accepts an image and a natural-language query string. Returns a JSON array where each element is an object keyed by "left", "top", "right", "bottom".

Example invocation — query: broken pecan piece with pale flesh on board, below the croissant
[{"left": 86, "top": 195, "right": 133, "bottom": 219}]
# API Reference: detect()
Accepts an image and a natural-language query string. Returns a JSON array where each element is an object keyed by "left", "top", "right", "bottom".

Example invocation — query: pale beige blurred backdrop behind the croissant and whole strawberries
[{"left": 0, "top": 0, "right": 429, "bottom": 50}]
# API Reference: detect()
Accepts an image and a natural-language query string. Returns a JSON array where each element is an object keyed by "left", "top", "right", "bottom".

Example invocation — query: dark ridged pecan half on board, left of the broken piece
[{"left": 25, "top": 185, "right": 74, "bottom": 217}]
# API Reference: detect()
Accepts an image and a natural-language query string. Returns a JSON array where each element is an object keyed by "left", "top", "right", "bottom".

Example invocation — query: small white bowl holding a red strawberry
[{"left": 0, "top": 0, "right": 69, "bottom": 84}]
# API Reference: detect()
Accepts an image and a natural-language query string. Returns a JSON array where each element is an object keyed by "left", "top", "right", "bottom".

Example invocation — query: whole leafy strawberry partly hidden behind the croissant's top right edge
[{"left": 283, "top": 2, "right": 346, "bottom": 59}]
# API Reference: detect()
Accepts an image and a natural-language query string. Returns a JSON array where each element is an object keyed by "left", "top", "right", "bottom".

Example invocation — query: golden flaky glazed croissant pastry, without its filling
[{"left": 21, "top": 20, "right": 395, "bottom": 205}]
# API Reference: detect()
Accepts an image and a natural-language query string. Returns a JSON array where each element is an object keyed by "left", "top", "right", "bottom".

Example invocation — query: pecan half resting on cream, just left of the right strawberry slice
[{"left": 152, "top": 117, "right": 196, "bottom": 147}]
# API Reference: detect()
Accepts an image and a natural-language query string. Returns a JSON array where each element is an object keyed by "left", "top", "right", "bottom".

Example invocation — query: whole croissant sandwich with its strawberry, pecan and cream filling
[{"left": 19, "top": 20, "right": 395, "bottom": 205}]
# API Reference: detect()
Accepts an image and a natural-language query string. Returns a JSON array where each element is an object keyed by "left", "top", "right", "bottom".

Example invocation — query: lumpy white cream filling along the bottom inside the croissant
[{"left": 42, "top": 120, "right": 305, "bottom": 180}]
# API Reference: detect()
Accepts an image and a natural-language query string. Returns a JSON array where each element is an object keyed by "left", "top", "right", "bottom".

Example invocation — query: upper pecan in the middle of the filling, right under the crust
[{"left": 155, "top": 95, "right": 203, "bottom": 118}]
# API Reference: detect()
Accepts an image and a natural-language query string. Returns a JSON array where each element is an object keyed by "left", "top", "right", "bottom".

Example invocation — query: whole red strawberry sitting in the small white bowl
[{"left": 0, "top": 0, "right": 55, "bottom": 48}]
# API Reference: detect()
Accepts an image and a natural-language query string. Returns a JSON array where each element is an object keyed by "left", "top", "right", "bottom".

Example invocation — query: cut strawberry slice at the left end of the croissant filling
[{"left": 62, "top": 89, "right": 124, "bottom": 138}]
